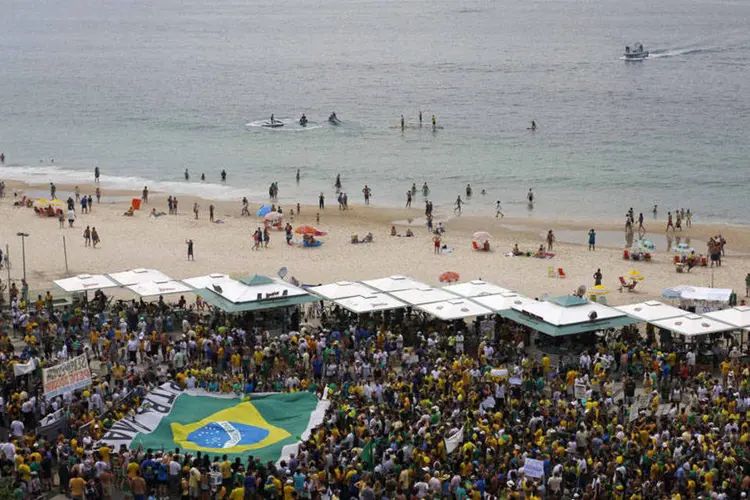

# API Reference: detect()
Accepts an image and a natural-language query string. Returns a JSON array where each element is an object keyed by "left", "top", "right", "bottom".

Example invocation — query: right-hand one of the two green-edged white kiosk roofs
[{"left": 498, "top": 297, "right": 636, "bottom": 337}]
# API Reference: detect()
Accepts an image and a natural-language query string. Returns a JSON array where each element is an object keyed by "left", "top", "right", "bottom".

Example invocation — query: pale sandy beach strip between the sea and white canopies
[{"left": 0, "top": 183, "right": 750, "bottom": 304}]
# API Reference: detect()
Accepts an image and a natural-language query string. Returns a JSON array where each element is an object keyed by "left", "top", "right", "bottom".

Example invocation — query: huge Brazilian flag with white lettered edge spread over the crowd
[{"left": 102, "top": 384, "right": 327, "bottom": 461}]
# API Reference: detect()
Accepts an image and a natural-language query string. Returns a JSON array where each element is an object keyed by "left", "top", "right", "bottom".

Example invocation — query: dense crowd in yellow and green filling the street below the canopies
[{"left": 0, "top": 296, "right": 750, "bottom": 500}]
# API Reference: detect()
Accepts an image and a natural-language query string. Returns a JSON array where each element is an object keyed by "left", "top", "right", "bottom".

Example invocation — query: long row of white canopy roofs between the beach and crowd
[{"left": 55, "top": 269, "right": 750, "bottom": 337}]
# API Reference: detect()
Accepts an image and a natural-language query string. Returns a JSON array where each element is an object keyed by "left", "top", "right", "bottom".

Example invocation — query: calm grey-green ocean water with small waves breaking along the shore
[{"left": 0, "top": 0, "right": 750, "bottom": 223}]
